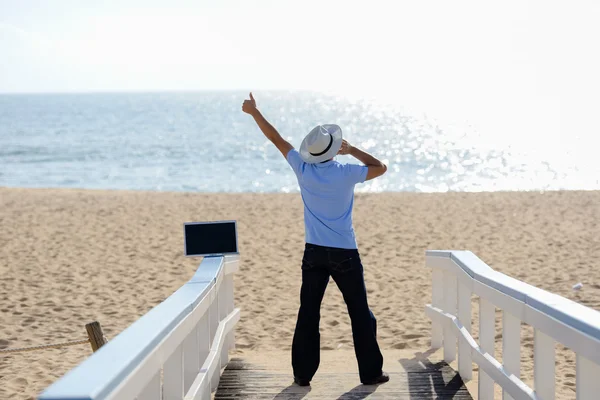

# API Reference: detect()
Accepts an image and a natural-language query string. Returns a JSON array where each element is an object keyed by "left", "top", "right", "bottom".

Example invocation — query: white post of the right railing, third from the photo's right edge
[{"left": 502, "top": 310, "right": 521, "bottom": 400}]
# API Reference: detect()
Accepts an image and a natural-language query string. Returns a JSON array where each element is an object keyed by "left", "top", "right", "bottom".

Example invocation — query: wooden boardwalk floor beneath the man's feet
[{"left": 214, "top": 350, "right": 472, "bottom": 400}]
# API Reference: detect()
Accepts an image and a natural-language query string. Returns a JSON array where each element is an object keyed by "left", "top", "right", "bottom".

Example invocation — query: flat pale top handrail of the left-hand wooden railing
[{"left": 39, "top": 256, "right": 238, "bottom": 400}]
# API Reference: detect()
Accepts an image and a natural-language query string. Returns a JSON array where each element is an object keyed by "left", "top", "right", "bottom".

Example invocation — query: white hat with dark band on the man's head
[{"left": 300, "top": 124, "right": 342, "bottom": 164}]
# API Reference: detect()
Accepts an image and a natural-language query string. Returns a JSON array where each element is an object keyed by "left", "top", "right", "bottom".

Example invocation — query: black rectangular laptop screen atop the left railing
[{"left": 184, "top": 221, "right": 238, "bottom": 256}]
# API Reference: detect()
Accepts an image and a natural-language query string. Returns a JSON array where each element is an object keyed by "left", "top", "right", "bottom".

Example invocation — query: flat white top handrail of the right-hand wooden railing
[{"left": 426, "top": 250, "right": 600, "bottom": 341}]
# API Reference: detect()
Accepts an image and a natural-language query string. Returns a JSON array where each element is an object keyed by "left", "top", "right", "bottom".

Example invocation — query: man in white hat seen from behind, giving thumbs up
[{"left": 242, "top": 93, "right": 389, "bottom": 386}]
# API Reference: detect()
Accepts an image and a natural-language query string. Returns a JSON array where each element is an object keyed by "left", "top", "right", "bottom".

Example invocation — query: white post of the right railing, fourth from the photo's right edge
[{"left": 478, "top": 297, "right": 496, "bottom": 400}]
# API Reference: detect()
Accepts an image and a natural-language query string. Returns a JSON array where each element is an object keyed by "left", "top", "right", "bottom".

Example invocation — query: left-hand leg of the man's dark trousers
[{"left": 292, "top": 249, "right": 329, "bottom": 381}]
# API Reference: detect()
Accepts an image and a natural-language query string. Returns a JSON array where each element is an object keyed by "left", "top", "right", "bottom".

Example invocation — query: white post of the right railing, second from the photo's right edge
[{"left": 533, "top": 329, "right": 556, "bottom": 400}]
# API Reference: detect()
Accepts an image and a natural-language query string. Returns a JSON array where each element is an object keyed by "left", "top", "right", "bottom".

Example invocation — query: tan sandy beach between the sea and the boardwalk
[{"left": 0, "top": 188, "right": 600, "bottom": 399}]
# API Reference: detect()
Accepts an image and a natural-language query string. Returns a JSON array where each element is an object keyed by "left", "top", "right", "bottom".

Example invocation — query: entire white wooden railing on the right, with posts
[{"left": 426, "top": 251, "right": 600, "bottom": 400}]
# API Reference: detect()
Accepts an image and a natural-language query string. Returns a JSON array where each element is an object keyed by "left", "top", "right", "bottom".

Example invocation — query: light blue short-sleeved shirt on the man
[{"left": 287, "top": 149, "right": 368, "bottom": 249}]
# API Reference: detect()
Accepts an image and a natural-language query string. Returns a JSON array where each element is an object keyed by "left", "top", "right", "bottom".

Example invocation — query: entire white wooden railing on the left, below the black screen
[{"left": 38, "top": 256, "right": 240, "bottom": 400}]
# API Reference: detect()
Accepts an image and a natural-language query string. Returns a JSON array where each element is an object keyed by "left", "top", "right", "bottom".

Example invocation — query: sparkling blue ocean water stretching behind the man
[{"left": 0, "top": 91, "right": 600, "bottom": 192}]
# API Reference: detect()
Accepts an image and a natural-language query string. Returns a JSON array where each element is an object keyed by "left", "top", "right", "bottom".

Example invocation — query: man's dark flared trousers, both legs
[{"left": 292, "top": 243, "right": 383, "bottom": 382}]
